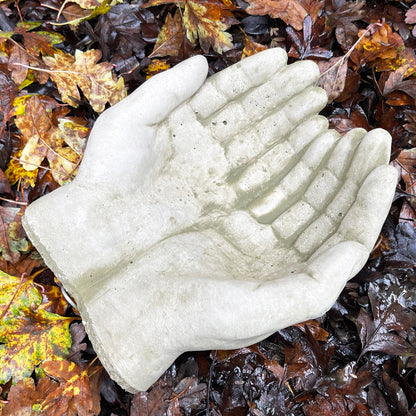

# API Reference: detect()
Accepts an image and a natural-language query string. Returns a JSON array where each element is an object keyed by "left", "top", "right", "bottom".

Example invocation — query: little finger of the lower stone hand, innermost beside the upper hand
[{"left": 249, "top": 130, "right": 339, "bottom": 223}]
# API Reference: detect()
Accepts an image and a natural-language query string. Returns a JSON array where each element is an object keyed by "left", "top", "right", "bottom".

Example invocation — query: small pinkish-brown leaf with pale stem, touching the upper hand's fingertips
[{"left": 317, "top": 56, "right": 348, "bottom": 103}]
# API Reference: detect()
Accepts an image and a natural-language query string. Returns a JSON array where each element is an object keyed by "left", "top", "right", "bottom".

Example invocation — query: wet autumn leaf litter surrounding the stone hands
[{"left": 0, "top": 0, "right": 416, "bottom": 416}]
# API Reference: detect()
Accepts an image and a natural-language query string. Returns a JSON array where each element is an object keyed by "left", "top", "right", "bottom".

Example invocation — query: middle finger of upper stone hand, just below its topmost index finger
[{"left": 208, "top": 61, "right": 322, "bottom": 144}]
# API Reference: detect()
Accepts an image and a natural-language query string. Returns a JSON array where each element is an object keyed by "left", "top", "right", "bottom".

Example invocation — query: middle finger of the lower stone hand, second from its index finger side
[{"left": 294, "top": 129, "right": 394, "bottom": 256}]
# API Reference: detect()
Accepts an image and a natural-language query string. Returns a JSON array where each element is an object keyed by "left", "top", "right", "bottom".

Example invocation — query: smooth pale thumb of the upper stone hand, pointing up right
[{"left": 120, "top": 55, "right": 208, "bottom": 125}]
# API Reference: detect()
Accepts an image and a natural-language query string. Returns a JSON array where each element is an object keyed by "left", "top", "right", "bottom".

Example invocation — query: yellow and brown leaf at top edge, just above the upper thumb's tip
[{"left": 142, "top": 0, "right": 236, "bottom": 53}]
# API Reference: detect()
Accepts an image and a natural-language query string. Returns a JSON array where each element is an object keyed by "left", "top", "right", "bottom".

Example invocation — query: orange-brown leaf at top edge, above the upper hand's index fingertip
[{"left": 245, "top": 0, "right": 307, "bottom": 30}]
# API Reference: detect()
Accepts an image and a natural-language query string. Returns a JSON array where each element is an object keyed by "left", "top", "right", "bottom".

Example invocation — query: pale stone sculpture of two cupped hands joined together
[{"left": 24, "top": 49, "right": 397, "bottom": 392}]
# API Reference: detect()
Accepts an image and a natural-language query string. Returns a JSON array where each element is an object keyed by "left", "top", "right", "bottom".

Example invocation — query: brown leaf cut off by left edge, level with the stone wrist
[{"left": 0, "top": 206, "right": 30, "bottom": 263}]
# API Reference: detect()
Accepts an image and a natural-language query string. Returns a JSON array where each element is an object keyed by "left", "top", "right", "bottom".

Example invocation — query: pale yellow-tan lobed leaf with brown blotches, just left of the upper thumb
[{"left": 43, "top": 49, "right": 126, "bottom": 113}]
